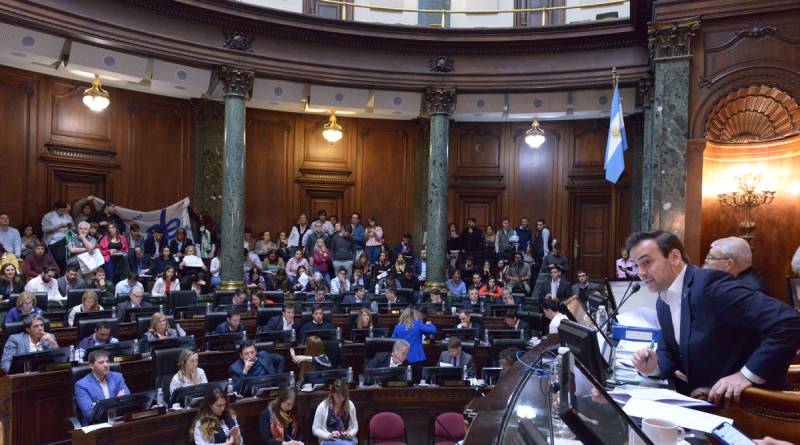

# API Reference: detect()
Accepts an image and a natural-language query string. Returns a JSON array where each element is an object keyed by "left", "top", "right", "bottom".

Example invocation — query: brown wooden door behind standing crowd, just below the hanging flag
[{"left": 563, "top": 196, "right": 611, "bottom": 280}]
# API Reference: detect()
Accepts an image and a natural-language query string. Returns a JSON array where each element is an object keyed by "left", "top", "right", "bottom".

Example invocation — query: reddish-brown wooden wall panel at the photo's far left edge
[{"left": 0, "top": 72, "right": 36, "bottom": 226}]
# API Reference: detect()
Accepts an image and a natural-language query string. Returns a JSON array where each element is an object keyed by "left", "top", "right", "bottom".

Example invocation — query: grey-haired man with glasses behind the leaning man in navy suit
[{"left": 703, "top": 236, "right": 768, "bottom": 294}]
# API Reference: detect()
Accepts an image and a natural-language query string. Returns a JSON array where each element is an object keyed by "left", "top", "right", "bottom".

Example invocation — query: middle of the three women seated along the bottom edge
[{"left": 258, "top": 388, "right": 303, "bottom": 445}]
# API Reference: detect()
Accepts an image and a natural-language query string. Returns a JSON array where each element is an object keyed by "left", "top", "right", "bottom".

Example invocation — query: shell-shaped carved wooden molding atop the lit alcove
[{"left": 706, "top": 85, "right": 800, "bottom": 144}]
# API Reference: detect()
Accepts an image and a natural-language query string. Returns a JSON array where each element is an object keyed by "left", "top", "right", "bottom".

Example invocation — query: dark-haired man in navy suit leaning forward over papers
[{"left": 625, "top": 230, "right": 800, "bottom": 404}]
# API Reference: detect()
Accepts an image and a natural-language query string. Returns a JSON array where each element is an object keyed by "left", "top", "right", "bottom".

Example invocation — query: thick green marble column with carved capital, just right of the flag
[{"left": 642, "top": 19, "right": 699, "bottom": 239}]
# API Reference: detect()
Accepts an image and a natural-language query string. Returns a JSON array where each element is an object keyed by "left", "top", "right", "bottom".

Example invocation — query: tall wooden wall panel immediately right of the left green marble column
[{"left": 244, "top": 110, "right": 294, "bottom": 234}]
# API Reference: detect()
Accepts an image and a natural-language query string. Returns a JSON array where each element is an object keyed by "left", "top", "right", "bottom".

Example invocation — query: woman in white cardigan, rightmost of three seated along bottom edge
[{"left": 312, "top": 380, "right": 358, "bottom": 445}]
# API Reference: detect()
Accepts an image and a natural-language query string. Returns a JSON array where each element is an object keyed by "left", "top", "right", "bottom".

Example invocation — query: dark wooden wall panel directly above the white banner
[{"left": 125, "top": 91, "right": 194, "bottom": 210}]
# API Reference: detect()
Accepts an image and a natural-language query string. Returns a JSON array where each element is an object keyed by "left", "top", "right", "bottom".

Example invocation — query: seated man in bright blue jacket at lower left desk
[{"left": 75, "top": 350, "right": 131, "bottom": 423}]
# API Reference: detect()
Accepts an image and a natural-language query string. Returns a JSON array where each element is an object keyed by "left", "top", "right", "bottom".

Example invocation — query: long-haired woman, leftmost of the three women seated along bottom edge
[{"left": 192, "top": 388, "right": 244, "bottom": 445}]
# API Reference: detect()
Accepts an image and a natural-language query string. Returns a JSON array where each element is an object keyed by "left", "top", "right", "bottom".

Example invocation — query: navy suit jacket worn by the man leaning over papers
[{"left": 656, "top": 266, "right": 800, "bottom": 391}]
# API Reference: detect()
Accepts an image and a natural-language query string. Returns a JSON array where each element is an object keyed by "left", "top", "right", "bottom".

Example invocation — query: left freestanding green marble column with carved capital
[{"left": 218, "top": 66, "right": 254, "bottom": 290}]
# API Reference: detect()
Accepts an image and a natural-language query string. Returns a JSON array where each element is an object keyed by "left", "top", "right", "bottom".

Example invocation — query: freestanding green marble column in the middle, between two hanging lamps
[{"left": 425, "top": 87, "right": 455, "bottom": 288}]
